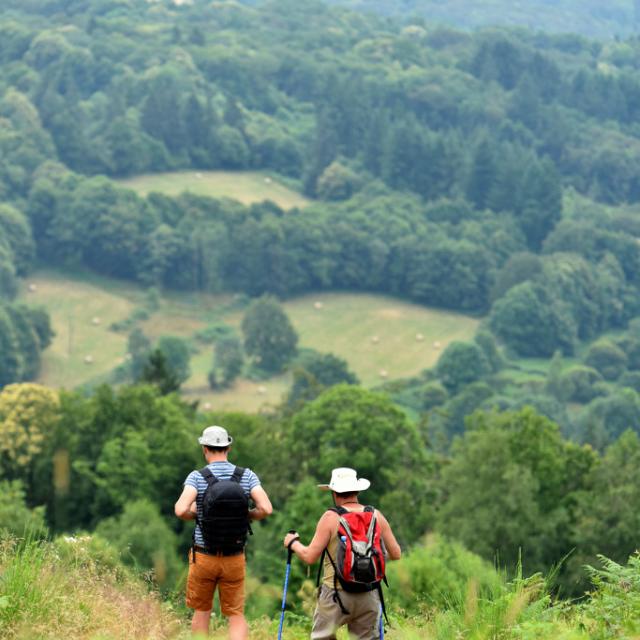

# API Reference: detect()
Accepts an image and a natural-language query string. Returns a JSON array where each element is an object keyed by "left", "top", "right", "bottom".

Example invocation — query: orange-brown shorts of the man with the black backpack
[{"left": 187, "top": 551, "right": 246, "bottom": 616}]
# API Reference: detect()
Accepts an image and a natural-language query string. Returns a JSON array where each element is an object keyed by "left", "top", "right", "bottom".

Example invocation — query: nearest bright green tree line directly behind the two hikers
[{"left": 5, "top": 376, "right": 640, "bottom": 594}]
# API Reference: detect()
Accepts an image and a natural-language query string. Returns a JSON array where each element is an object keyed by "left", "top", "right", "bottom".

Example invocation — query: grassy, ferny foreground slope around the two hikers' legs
[{"left": 6, "top": 536, "right": 640, "bottom": 640}]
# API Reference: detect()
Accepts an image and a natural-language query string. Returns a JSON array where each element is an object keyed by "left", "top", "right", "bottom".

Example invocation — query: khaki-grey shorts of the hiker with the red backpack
[{"left": 311, "top": 585, "right": 382, "bottom": 640}]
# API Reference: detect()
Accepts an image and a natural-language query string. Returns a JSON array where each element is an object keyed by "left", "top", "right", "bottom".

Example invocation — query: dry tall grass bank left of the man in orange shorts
[{"left": 0, "top": 537, "right": 182, "bottom": 640}]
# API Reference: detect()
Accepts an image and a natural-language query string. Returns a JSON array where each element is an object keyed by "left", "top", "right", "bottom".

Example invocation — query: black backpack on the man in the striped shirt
[{"left": 194, "top": 467, "right": 250, "bottom": 555}]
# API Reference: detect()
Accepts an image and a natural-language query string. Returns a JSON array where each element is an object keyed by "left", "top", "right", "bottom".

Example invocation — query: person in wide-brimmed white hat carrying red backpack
[{"left": 284, "top": 467, "right": 402, "bottom": 640}]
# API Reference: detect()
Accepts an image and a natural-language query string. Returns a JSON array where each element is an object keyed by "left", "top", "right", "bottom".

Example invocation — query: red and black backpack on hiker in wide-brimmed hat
[{"left": 318, "top": 507, "right": 386, "bottom": 614}]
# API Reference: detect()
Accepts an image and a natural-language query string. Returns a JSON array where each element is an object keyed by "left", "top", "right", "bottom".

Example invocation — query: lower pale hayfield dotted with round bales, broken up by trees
[{"left": 21, "top": 272, "right": 479, "bottom": 411}]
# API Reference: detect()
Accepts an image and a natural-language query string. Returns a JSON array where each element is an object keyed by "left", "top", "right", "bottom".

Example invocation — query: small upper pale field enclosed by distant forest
[{"left": 119, "top": 171, "right": 309, "bottom": 209}]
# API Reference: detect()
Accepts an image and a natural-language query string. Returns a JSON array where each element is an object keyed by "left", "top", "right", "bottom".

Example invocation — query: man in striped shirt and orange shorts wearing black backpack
[{"left": 175, "top": 425, "right": 272, "bottom": 640}]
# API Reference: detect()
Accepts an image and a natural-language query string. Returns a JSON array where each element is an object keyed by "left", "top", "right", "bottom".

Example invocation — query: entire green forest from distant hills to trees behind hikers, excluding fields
[{"left": 0, "top": 0, "right": 640, "bottom": 638}]
